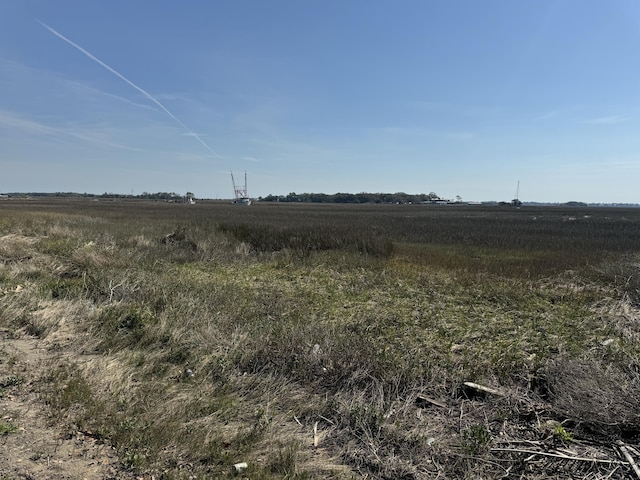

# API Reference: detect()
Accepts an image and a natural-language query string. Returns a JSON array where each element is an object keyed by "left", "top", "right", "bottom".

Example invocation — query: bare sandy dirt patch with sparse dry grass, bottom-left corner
[{"left": 0, "top": 332, "right": 134, "bottom": 480}]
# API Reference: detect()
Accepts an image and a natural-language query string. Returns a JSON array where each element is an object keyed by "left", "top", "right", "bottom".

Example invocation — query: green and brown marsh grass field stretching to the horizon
[{"left": 0, "top": 199, "right": 640, "bottom": 479}]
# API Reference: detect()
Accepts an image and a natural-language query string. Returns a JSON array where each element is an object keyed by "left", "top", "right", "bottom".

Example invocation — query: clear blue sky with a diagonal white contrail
[{"left": 0, "top": 0, "right": 640, "bottom": 203}]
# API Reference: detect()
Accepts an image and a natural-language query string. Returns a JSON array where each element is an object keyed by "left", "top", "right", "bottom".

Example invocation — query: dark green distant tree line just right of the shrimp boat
[{"left": 258, "top": 192, "right": 441, "bottom": 203}]
